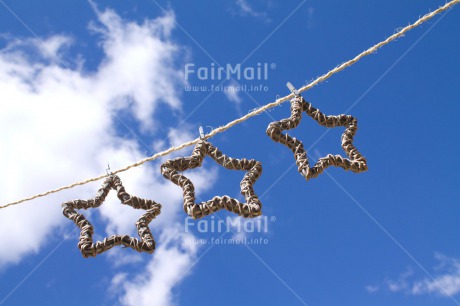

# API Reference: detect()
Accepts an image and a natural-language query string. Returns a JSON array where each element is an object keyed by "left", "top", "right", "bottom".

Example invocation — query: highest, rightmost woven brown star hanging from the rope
[{"left": 267, "top": 95, "right": 367, "bottom": 180}]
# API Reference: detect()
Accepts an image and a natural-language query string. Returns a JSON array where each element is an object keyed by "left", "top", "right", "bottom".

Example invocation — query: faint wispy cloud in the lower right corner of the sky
[{"left": 374, "top": 254, "right": 460, "bottom": 297}]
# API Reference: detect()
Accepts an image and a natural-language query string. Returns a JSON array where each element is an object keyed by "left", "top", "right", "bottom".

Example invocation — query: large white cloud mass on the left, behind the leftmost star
[{"left": 0, "top": 4, "right": 216, "bottom": 305}]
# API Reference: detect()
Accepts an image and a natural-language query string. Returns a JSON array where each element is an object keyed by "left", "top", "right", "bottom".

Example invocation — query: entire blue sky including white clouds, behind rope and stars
[{"left": 0, "top": 0, "right": 460, "bottom": 306}]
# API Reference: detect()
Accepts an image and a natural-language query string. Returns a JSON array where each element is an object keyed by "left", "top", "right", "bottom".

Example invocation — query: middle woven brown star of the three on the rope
[{"left": 161, "top": 140, "right": 262, "bottom": 219}]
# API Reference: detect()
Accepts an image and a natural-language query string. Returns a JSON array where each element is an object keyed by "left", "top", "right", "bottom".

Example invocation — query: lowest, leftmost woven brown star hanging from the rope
[{"left": 62, "top": 174, "right": 161, "bottom": 258}]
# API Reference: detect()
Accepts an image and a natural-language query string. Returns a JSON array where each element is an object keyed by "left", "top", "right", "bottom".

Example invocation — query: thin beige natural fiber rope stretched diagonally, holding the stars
[{"left": 0, "top": 0, "right": 460, "bottom": 209}]
